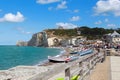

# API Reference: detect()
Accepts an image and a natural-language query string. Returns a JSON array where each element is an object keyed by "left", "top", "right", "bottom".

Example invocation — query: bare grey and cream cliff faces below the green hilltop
[{"left": 17, "top": 30, "right": 83, "bottom": 47}]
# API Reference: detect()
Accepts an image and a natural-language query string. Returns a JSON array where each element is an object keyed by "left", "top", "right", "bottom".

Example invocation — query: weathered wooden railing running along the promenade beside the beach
[{"left": 65, "top": 49, "right": 105, "bottom": 80}]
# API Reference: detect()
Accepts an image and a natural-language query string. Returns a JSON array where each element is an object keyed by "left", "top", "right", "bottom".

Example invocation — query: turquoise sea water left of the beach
[{"left": 0, "top": 46, "right": 61, "bottom": 70}]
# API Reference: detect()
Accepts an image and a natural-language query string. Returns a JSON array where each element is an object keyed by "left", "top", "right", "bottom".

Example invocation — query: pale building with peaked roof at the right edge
[{"left": 104, "top": 31, "right": 120, "bottom": 43}]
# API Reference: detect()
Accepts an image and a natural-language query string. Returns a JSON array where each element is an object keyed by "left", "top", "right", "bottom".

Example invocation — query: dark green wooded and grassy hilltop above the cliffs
[{"left": 45, "top": 26, "right": 117, "bottom": 39}]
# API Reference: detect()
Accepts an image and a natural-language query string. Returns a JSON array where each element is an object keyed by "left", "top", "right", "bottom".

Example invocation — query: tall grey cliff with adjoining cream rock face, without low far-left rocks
[{"left": 28, "top": 32, "right": 61, "bottom": 47}]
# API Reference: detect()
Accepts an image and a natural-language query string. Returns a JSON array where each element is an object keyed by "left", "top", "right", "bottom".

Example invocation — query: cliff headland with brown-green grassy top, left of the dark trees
[{"left": 17, "top": 29, "right": 83, "bottom": 47}]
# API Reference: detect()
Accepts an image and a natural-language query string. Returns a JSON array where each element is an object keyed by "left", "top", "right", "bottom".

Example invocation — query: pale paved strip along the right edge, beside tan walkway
[{"left": 110, "top": 56, "right": 120, "bottom": 80}]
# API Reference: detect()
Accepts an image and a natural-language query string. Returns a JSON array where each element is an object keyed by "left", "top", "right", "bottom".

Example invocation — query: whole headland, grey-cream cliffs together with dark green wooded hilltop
[{"left": 17, "top": 26, "right": 120, "bottom": 47}]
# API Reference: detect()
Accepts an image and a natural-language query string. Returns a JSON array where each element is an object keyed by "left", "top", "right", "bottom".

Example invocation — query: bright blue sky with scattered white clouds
[{"left": 0, "top": 0, "right": 120, "bottom": 45}]
